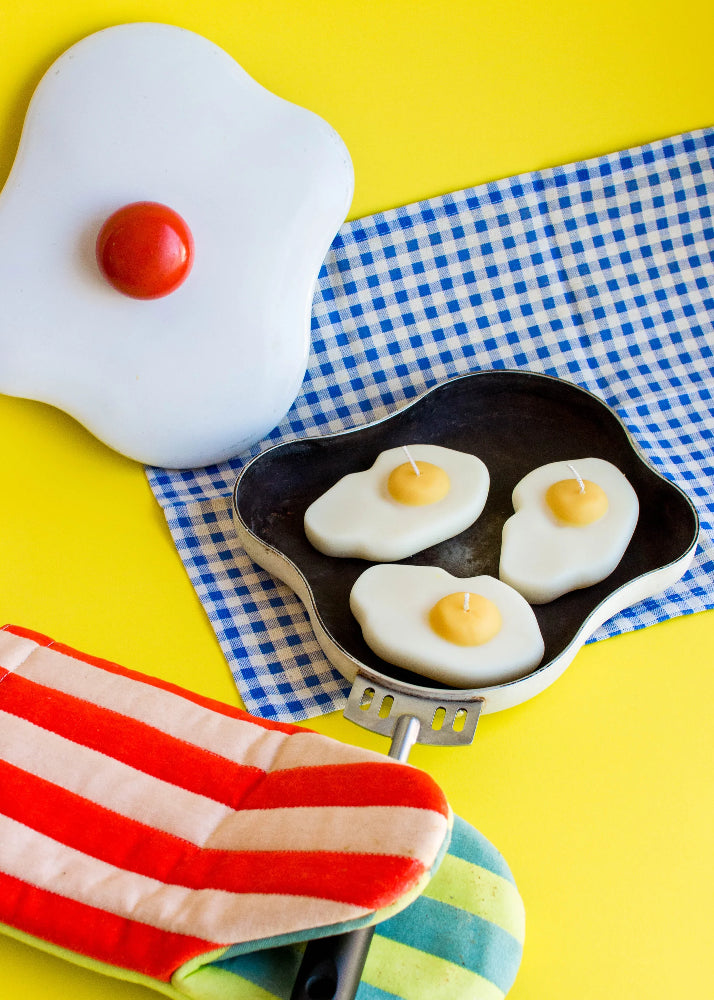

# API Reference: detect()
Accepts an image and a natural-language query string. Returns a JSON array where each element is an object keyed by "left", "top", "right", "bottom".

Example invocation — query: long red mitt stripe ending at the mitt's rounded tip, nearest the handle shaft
[{"left": 2, "top": 674, "right": 448, "bottom": 816}]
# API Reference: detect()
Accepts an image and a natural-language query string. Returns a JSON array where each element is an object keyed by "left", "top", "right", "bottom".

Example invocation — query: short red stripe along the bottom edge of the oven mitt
[{"left": 0, "top": 872, "right": 221, "bottom": 982}]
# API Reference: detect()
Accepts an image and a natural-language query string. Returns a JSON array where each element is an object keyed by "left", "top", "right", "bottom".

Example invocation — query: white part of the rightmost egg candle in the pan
[{"left": 499, "top": 458, "right": 639, "bottom": 604}]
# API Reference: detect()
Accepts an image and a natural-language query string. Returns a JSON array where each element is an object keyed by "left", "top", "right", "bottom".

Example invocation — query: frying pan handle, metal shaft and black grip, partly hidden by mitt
[{"left": 290, "top": 715, "right": 421, "bottom": 1000}]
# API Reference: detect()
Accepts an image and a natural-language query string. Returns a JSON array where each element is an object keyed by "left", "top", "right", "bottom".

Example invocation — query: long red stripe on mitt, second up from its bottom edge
[{"left": 0, "top": 761, "right": 424, "bottom": 909}]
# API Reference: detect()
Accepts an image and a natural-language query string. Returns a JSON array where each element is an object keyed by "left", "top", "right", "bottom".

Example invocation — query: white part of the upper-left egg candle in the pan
[{"left": 305, "top": 444, "right": 489, "bottom": 562}]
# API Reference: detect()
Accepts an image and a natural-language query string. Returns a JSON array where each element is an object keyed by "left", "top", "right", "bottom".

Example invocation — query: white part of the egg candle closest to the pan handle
[{"left": 350, "top": 565, "right": 544, "bottom": 688}]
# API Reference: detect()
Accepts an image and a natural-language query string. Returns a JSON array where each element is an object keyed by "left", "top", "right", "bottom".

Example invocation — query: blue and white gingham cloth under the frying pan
[{"left": 147, "top": 129, "right": 714, "bottom": 720}]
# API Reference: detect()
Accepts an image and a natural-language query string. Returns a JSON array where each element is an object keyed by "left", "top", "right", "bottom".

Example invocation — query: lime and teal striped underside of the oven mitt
[{"left": 195, "top": 817, "right": 525, "bottom": 1000}]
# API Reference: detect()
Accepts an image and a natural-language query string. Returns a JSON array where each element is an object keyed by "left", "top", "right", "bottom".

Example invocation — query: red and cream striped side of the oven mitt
[{"left": 0, "top": 626, "right": 451, "bottom": 981}]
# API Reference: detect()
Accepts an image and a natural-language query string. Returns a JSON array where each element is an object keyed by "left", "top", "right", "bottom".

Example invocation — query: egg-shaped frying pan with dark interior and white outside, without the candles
[{"left": 233, "top": 371, "right": 699, "bottom": 712}]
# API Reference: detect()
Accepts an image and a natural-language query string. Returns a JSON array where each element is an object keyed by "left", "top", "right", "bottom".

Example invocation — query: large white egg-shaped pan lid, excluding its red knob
[{"left": 0, "top": 23, "right": 354, "bottom": 467}]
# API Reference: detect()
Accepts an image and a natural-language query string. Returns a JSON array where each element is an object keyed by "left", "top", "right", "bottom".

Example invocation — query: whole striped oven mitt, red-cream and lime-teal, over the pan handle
[{"left": 0, "top": 626, "right": 523, "bottom": 1000}]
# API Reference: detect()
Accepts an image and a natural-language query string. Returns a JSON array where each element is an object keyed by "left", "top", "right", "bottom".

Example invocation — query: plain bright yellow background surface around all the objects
[{"left": 0, "top": 0, "right": 714, "bottom": 1000}]
